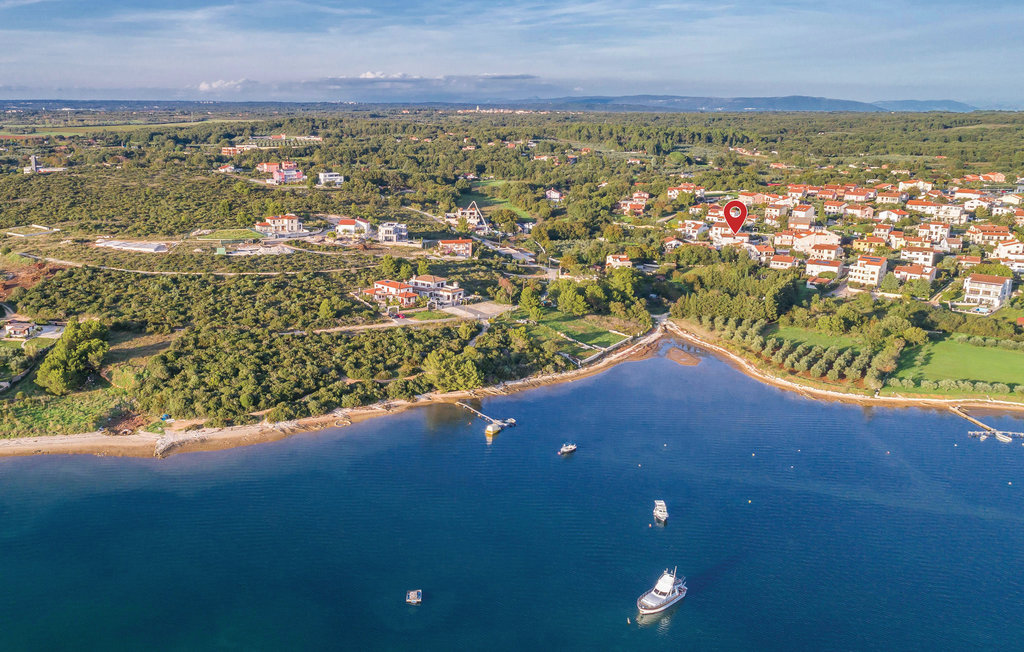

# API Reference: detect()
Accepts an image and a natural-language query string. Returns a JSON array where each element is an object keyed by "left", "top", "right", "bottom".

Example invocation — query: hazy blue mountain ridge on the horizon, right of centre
[{"left": 512, "top": 95, "right": 980, "bottom": 113}]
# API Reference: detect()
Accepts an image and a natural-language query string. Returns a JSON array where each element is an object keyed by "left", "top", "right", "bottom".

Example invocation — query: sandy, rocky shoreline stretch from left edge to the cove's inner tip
[{"left": 0, "top": 324, "right": 665, "bottom": 458}]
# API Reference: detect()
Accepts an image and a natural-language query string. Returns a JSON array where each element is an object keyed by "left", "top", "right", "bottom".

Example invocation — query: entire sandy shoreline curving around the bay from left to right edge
[{"left": 0, "top": 319, "right": 1024, "bottom": 458}]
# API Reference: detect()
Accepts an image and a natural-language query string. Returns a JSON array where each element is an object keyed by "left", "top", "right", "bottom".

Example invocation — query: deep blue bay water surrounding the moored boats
[{"left": 0, "top": 343, "right": 1024, "bottom": 651}]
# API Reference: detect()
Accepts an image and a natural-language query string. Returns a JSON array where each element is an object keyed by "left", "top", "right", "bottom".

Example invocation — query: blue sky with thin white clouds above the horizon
[{"left": 0, "top": 0, "right": 1024, "bottom": 108}]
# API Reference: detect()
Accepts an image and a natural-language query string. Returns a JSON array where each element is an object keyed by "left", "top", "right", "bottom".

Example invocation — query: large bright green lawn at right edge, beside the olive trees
[{"left": 896, "top": 340, "right": 1024, "bottom": 385}]
